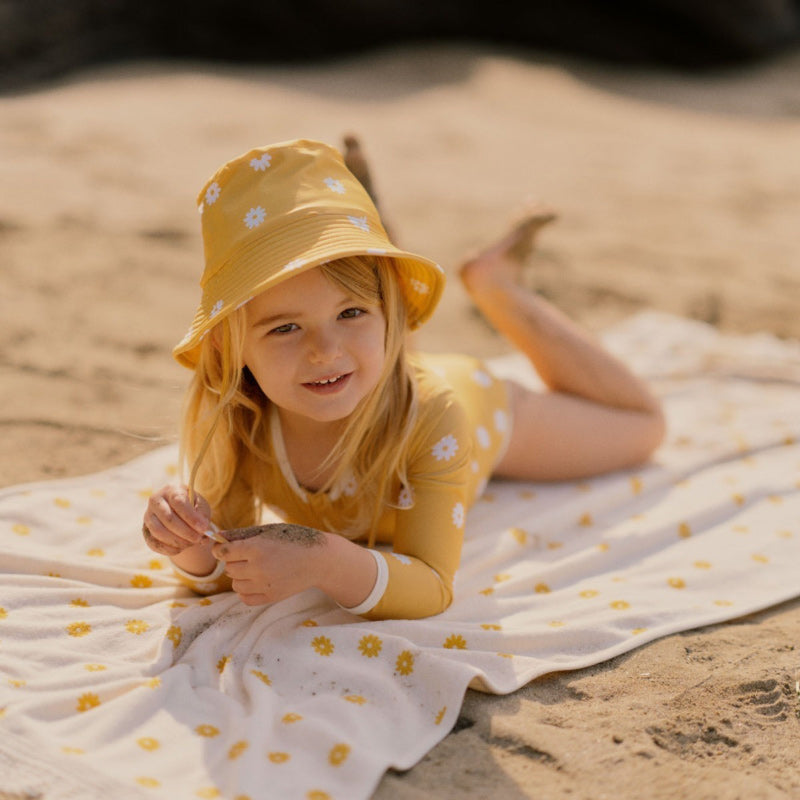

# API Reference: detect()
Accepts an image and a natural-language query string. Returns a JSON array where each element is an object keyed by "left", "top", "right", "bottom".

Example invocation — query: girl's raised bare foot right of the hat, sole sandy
[{"left": 459, "top": 206, "right": 557, "bottom": 293}]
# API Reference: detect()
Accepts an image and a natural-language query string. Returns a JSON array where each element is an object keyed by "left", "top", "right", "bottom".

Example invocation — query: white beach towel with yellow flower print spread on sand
[{"left": 0, "top": 314, "right": 800, "bottom": 800}]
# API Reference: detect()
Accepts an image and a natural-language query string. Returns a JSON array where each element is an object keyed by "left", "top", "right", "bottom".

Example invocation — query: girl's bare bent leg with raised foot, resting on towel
[{"left": 460, "top": 209, "right": 664, "bottom": 480}]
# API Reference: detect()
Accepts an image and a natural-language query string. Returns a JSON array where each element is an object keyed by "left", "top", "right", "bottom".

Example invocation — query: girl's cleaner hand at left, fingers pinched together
[{"left": 142, "top": 486, "right": 212, "bottom": 557}]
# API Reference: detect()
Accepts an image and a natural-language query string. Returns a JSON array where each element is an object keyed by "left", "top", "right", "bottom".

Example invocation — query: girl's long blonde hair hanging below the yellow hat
[{"left": 181, "top": 256, "right": 417, "bottom": 544}]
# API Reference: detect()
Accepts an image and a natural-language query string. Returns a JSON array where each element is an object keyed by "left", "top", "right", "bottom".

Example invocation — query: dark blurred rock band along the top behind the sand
[{"left": 0, "top": 0, "right": 800, "bottom": 90}]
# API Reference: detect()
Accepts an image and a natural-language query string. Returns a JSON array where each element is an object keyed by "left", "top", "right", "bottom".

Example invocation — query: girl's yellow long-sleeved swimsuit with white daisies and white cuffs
[{"left": 177, "top": 355, "right": 511, "bottom": 619}]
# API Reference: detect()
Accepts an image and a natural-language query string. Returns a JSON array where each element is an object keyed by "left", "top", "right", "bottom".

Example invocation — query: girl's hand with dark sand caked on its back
[{"left": 212, "top": 524, "right": 328, "bottom": 606}]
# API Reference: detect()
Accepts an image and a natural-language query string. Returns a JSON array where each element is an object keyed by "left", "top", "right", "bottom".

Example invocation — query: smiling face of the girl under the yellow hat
[{"left": 244, "top": 269, "right": 385, "bottom": 432}]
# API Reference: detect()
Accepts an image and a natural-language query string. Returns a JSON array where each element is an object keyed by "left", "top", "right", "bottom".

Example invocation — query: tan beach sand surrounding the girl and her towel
[{"left": 0, "top": 46, "right": 800, "bottom": 800}]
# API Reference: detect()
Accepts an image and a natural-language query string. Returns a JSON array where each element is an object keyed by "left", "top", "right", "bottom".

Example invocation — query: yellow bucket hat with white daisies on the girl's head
[{"left": 172, "top": 139, "right": 444, "bottom": 368}]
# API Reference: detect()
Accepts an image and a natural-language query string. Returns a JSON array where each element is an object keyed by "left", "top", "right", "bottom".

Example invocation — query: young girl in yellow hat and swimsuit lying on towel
[{"left": 144, "top": 140, "right": 664, "bottom": 619}]
